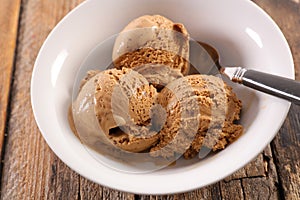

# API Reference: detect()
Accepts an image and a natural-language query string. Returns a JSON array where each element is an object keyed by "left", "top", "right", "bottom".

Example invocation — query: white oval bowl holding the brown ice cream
[{"left": 31, "top": 0, "right": 294, "bottom": 194}]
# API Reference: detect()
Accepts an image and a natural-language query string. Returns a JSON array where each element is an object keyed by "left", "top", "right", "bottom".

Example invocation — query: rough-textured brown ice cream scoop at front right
[{"left": 151, "top": 75, "right": 243, "bottom": 158}]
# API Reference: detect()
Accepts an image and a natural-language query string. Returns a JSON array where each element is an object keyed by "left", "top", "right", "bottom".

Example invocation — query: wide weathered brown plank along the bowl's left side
[{"left": 1, "top": 0, "right": 134, "bottom": 199}]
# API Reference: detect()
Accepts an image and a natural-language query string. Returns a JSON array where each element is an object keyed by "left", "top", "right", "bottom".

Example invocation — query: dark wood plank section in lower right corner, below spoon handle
[{"left": 272, "top": 104, "right": 300, "bottom": 199}]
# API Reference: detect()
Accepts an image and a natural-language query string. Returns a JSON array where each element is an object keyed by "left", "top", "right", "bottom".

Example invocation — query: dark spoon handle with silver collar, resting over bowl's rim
[{"left": 224, "top": 67, "right": 300, "bottom": 105}]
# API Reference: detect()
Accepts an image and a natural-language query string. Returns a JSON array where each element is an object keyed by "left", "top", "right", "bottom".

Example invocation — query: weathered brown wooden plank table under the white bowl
[{"left": 0, "top": 0, "right": 300, "bottom": 200}]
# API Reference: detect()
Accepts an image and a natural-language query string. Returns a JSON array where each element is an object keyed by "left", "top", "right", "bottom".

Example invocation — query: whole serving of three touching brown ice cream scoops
[{"left": 72, "top": 15, "right": 243, "bottom": 160}]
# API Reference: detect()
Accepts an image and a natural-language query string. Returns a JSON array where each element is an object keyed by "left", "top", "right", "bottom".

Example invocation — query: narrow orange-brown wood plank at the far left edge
[{"left": 0, "top": 0, "right": 21, "bottom": 157}]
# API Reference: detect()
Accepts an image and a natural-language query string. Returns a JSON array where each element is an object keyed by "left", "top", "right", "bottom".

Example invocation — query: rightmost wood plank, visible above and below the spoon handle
[{"left": 253, "top": 0, "right": 300, "bottom": 199}]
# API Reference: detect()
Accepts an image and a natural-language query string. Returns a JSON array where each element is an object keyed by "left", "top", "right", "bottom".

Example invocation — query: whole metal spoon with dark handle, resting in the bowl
[{"left": 191, "top": 42, "right": 300, "bottom": 105}]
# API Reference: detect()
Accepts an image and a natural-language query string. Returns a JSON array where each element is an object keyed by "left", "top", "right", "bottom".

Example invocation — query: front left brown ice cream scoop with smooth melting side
[{"left": 73, "top": 68, "right": 159, "bottom": 152}]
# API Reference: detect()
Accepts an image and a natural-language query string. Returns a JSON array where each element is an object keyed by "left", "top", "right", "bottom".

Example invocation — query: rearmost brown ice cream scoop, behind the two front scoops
[{"left": 112, "top": 15, "right": 189, "bottom": 86}]
